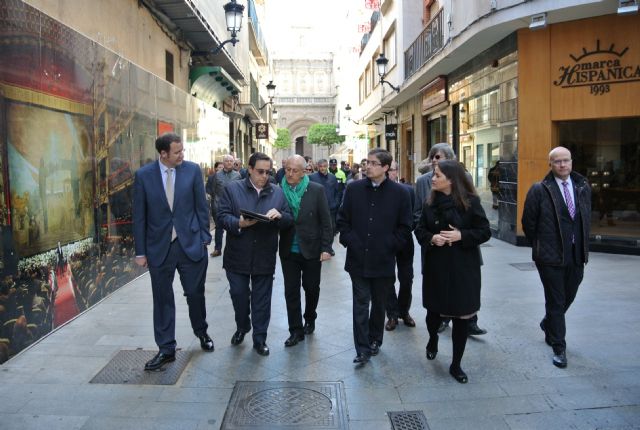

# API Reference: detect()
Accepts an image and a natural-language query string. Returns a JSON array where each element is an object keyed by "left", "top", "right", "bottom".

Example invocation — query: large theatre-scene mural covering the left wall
[{"left": 0, "top": 0, "right": 228, "bottom": 363}]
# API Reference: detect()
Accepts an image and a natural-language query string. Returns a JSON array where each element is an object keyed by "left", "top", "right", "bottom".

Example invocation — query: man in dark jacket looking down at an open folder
[{"left": 218, "top": 152, "right": 293, "bottom": 356}]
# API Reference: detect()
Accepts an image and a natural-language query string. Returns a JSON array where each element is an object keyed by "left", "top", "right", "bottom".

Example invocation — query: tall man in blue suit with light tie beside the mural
[{"left": 133, "top": 133, "right": 214, "bottom": 370}]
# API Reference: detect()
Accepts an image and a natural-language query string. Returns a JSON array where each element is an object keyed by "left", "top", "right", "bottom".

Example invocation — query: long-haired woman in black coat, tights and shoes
[{"left": 415, "top": 160, "right": 491, "bottom": 384}]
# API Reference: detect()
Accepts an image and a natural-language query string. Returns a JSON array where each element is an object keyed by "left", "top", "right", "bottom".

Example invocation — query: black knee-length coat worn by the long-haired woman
[{"left": 415, "top": 193, "right": 491, "bottom": 316}]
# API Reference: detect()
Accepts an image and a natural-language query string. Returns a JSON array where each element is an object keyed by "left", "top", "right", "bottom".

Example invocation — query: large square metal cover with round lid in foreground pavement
[{"left": 220, "top": 381, "right": 348, "bottom": 430}]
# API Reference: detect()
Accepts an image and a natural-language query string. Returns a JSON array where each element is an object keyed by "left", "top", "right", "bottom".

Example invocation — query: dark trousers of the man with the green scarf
[{"left": 280, "top": 252, "right": 322, "bottom": 334}]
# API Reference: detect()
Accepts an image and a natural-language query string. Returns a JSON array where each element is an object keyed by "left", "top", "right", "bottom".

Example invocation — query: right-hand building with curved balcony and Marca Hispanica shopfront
[{"left": 354, "top": 0, "right": 640, "bottom": 254}]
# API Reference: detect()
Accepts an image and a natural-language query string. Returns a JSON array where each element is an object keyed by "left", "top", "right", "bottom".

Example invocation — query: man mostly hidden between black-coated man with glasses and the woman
[{"left": 385, "top": 161, "right": 416, "bottom": 331}]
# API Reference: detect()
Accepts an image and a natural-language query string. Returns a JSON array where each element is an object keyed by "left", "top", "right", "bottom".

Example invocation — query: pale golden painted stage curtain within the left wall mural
[{"left": 7, "top": 103, "right": 93, "bottom": 257}]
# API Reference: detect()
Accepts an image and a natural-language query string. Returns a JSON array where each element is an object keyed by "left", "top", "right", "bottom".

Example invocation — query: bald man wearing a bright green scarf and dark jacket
[{"left": 280, "top": 155, "right": 334, "bottom": 346}]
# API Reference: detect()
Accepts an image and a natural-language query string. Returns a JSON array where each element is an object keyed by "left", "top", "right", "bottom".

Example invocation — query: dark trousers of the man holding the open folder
[{"left": 227, "top": 270, "right": 273, "bottom": 345}]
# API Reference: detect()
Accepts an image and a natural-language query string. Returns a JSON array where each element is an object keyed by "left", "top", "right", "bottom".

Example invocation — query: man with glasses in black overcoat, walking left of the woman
[{"left": 337, "top": 148, "right": 413, "bottom": 364}]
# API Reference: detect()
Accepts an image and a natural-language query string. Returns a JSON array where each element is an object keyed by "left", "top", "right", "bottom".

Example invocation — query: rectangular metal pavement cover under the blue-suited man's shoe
[{"left": 91, "top": 349, "right": 191, "bottom": 385}]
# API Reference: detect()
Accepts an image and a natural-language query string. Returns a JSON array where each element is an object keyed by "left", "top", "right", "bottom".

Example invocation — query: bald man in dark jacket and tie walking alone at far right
[{"left": 522, "top": 146, "right": 591, "bottom": 368}]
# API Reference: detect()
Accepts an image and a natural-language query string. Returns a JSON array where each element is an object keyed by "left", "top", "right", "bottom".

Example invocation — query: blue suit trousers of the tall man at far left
[{"left": 149, "top": 240, "right": 209, "bottom": 354}]
